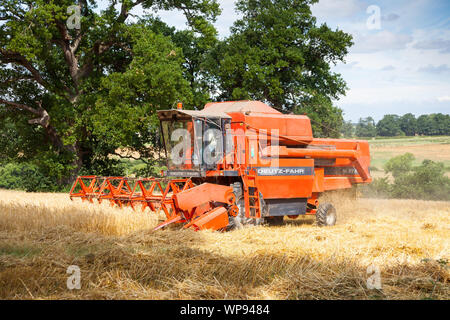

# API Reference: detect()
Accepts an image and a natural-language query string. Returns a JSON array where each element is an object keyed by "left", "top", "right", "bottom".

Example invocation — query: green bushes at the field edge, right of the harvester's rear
[{"left": 364, "top": 153, "right": 450, "bottom": 201}]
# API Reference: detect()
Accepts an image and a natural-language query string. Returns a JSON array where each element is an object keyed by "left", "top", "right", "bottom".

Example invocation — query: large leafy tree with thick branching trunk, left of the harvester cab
[{"left": 0, "top": 0, "right": 220, "bottom": 186}]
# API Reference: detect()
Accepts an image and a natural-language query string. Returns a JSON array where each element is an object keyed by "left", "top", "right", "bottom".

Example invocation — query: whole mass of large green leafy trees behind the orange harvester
[{"left": 0, "top": 0, "right": 352, "bottom": 190}]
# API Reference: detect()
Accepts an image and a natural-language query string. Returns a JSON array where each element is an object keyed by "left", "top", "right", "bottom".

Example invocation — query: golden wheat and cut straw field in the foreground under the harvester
[{"left": 0, "top": 190, "right": 450, "bottom": 299}]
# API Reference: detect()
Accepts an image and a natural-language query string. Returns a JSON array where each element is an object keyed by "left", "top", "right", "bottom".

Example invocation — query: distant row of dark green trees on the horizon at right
[{"left": 341, "top": 113, "right": 450, "bottom": 137}]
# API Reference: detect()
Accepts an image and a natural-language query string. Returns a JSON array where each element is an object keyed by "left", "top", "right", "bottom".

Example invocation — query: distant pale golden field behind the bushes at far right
[{"left": 369, "top": 136, "right": 450, "bottom": 177}]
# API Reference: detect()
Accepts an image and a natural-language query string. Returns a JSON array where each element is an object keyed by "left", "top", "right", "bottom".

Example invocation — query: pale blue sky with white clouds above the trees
[{"left": 104, "top": 0, "right": 450, "bottom": 122}]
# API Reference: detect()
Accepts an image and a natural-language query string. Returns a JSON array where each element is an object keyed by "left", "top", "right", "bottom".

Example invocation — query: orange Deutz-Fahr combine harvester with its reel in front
[{"left": 70, "top": 101, "right": 372, "bottom": 230}]
